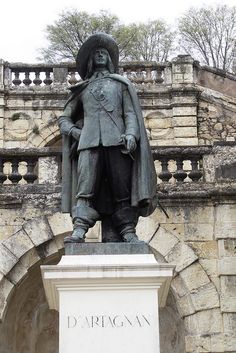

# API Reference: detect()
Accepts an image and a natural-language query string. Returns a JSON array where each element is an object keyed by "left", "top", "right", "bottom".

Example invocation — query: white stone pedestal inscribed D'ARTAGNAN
[{"left": 41, "top": 254, "right": 173, "bottom": 353}]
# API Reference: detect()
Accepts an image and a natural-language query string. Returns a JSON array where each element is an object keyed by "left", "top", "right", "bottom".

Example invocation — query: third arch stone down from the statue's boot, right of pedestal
[{"left": 165, "top": 242, "right": 197, "bottom": 272}]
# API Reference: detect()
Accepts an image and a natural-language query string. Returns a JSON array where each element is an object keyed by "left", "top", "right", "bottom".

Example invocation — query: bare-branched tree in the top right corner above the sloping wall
[{"left": 178, "top": 5, "right": 236, "bottom": 71}]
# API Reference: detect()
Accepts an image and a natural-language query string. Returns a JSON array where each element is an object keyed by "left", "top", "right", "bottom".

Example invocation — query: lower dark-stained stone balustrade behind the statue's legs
[{"left": 0, "top": 147, "right": 211, "bottom": 185}]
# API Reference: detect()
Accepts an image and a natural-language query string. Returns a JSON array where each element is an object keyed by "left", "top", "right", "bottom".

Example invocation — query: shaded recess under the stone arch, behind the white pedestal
[{"left": 0, "top": 255, "right": 185, "bottom": 353}]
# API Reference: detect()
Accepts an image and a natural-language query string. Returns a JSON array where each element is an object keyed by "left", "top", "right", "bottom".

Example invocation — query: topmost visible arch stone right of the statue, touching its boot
[{"left": 136, "top": 217, "right": 159, "bottom": 243}]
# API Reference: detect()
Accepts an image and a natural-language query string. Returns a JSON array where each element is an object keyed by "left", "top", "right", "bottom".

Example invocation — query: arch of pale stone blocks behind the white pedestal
[{"left": 0, "top": 212, "right": 220, "bottom": 353}]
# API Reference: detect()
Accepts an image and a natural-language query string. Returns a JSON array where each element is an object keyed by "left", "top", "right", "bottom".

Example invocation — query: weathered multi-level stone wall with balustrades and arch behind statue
[{"left": 0, "top": 56, "right": 236, "bottom": 353}]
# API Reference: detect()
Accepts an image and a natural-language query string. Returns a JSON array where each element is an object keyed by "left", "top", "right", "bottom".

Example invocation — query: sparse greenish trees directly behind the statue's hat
[{"left": 40, "top": 9, "right": 173, "bottom": 62}]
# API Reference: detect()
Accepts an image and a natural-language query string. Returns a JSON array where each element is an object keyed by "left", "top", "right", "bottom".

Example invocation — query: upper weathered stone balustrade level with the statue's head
[{"left": 4, "top": 62, "right": 168, "bottom": 88}]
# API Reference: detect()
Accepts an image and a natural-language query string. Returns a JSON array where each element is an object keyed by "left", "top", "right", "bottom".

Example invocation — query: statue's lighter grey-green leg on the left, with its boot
[{"left": 64, "top": 148, "right": 100, "bottom": 243}]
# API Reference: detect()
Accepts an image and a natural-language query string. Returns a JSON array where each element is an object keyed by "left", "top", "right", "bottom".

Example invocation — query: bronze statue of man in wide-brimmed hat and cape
[{"left": 59, "top": 33, "right": 156, "bottom": 243}]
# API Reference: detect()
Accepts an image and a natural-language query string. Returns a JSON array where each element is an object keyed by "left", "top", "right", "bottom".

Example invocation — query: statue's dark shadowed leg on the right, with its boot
[{"left": 106, "top": 147, "right": 143, "bottom": 243}]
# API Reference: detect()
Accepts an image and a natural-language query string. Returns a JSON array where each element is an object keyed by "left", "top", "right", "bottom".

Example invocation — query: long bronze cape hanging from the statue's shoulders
[{"left": 62, "top": 74, "right": 157, "bottom": 217}]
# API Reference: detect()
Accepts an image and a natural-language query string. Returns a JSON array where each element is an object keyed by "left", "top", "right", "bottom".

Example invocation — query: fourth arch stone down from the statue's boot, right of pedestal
[{"left": 179, "top": 262, "right": 210, "bottom": 292}]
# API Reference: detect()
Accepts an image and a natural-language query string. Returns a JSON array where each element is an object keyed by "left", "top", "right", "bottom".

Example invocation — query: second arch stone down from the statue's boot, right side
[{"left": 149, "top": 227, "right": 179, "bottom": 257}]
